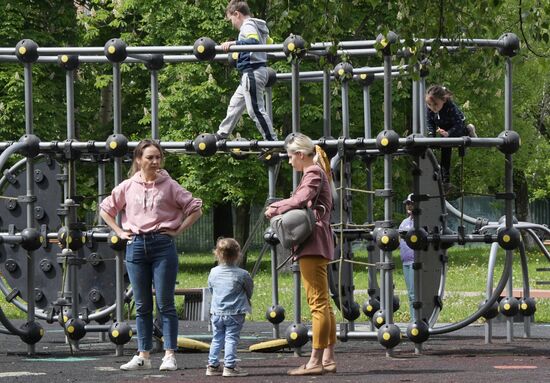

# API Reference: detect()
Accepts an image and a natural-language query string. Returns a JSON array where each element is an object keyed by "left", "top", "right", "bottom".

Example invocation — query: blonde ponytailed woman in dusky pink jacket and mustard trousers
[{"left": 265, "top": 133, "right": 336, "bottom": 375}]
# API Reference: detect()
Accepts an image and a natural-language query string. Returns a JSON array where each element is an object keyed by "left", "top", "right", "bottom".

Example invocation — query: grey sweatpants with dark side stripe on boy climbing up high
[{"left": 218, "top": 67, "right": 277, "bottom": 141}]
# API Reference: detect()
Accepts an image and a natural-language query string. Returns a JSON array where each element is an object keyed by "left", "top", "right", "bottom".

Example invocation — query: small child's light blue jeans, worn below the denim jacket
[{"left": 208, "top": 314, "right": 245, "bottom": 368}]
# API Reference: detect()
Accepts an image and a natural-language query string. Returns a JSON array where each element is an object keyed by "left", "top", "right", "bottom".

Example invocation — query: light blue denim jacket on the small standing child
[{"left": 208, "top": 265, "right": 254, "bottom": 315}]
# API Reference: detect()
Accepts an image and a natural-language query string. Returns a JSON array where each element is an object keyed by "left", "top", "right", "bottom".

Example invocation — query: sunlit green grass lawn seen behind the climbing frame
[{"left": 0, "top": 246, "right": 550, "bottom": 323}]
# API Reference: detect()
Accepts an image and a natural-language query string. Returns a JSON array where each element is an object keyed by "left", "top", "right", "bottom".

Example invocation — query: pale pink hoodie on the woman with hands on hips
[{"left": 99, "top": 170, "right": 202, "bottom": 234}]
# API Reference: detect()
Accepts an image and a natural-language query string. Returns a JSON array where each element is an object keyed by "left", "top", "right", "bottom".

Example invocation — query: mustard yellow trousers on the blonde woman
[{"left": 298, "top": 255, "right": 336, "bottom": 349}]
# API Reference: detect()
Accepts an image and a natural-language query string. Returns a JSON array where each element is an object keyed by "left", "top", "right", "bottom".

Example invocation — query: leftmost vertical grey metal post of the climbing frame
[{"left": 24, "top": 63, "right": 35, "bottom": 355}]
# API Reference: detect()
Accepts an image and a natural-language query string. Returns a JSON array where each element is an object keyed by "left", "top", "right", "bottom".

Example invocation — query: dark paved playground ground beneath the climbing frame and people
[{"left": 0, "top": 322, "right": 550, "bottom": 383}]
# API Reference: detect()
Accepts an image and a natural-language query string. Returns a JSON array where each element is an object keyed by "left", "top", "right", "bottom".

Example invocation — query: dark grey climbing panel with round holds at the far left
[{"left": 0, "top": 157, "right": 128, "bottom": 320}]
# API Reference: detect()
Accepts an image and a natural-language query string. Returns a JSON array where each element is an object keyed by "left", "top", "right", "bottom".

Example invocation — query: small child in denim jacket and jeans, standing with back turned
[{"left": 206, "top": 238, "right": 254, "bottom": 377}]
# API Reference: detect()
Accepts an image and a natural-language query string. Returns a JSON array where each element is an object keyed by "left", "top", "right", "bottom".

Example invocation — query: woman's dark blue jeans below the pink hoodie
[{"left": 126, "top": 233, "right": 178, "bottom": 351}]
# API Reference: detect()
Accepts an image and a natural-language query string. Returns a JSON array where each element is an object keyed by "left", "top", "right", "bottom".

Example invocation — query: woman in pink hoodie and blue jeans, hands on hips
[{"left": 100, "top": 140, "right": 202, "bottom": 371}]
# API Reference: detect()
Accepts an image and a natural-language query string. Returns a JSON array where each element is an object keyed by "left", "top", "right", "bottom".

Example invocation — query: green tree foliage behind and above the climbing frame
[{"left": 0, "top": 0, "right": 550, "bottom": 213}]
